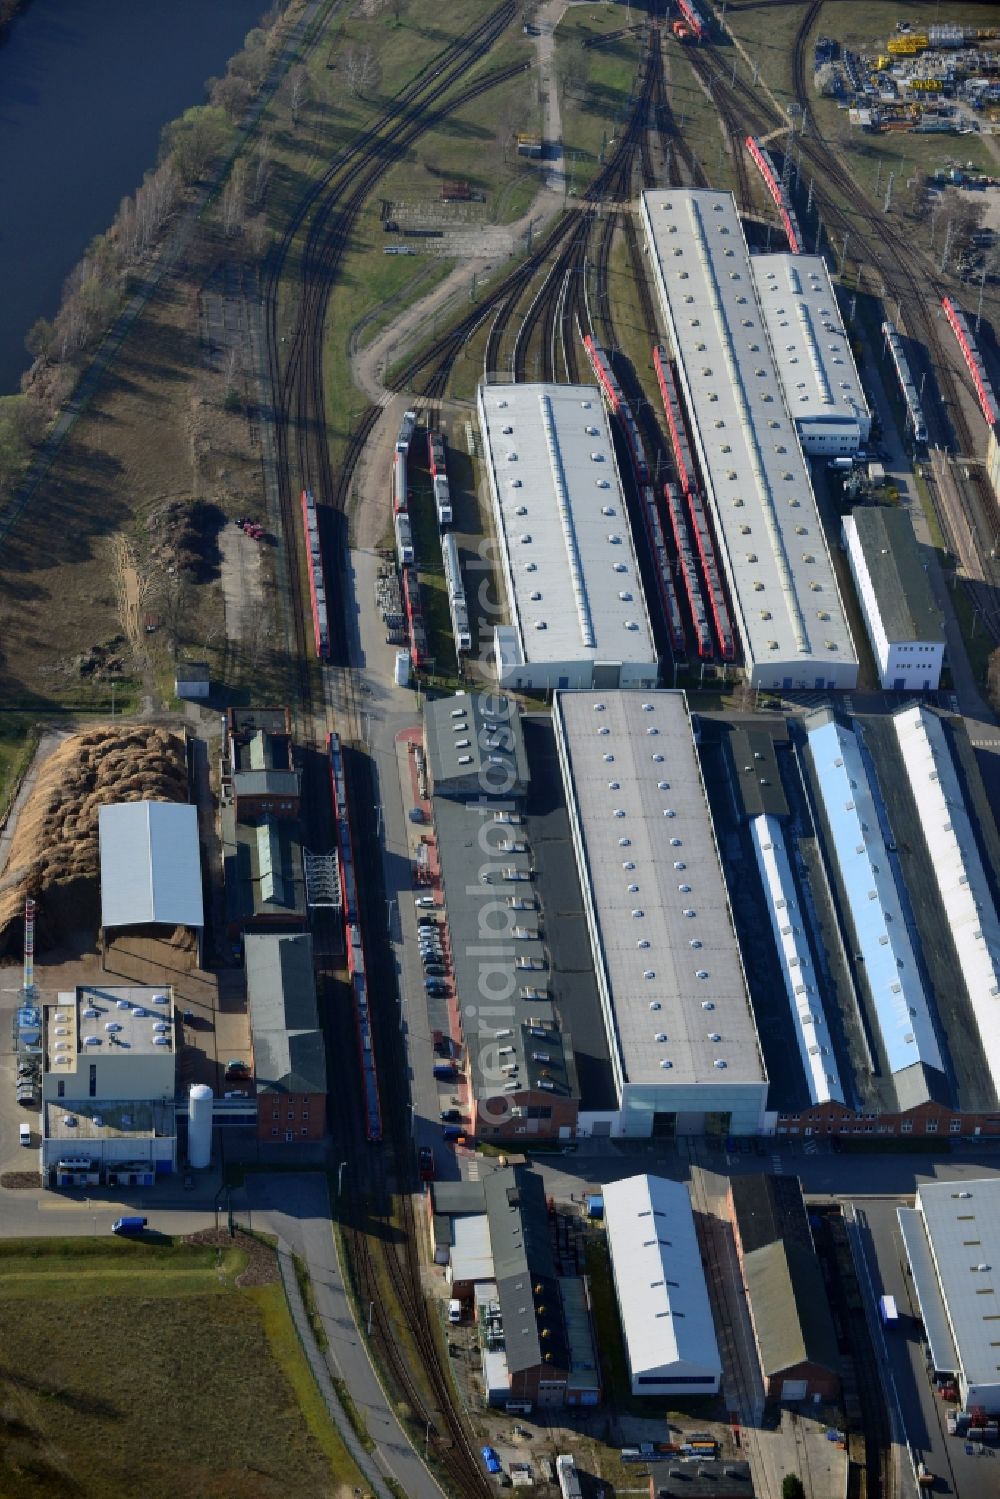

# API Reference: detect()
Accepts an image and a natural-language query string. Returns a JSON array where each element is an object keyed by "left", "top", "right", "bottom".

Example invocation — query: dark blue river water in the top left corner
[{"left": 0, "top": 0, "right": 265, "bottom": 394}]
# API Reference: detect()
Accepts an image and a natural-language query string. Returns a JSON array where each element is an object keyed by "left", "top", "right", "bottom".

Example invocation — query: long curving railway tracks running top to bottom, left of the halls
[{"left": 257, "top": 4, "right": 519, "bottom": 1496}]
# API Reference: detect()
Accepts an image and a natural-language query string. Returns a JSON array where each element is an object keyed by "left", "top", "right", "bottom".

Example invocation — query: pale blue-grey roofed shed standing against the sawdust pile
[{"left": 99, "top": 802, "right": 204, "bottom": 929}]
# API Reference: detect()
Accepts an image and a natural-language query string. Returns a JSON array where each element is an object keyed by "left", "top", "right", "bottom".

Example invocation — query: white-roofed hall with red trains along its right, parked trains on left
[{"left": 478, "top": 385, "right": 657, "bottom": 688}]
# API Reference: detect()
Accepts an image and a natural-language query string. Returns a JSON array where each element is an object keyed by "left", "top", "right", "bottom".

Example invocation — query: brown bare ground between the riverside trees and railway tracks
[{"left": 0, "top": 238, "right": 262, "bottom": 706}]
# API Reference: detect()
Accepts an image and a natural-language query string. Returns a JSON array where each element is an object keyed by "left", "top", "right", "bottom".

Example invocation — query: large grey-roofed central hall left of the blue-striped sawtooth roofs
[{"left": 555, "top": 691, "right": 768, "bottom": 1135}]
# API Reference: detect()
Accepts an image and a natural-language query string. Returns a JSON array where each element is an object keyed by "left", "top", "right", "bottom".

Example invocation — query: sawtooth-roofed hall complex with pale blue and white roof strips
[{"left": 767, "top": 708, "right": 1000, "bottom": 1138}]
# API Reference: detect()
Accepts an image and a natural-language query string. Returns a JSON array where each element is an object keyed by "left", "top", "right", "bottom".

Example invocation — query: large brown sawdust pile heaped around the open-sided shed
[{"left": 0, "top": 724, "right": 187, "bottom": 952}]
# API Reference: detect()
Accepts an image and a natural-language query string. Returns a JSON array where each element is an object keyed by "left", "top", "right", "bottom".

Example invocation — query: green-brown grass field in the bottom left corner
[{"left": 0, "top": 1238, "right": 358, "bottom": 1499}]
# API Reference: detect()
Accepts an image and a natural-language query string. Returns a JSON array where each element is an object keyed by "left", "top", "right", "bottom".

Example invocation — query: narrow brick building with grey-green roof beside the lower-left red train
[{"left": 244, "top": 932, "right": 327, "bottom": 1145}]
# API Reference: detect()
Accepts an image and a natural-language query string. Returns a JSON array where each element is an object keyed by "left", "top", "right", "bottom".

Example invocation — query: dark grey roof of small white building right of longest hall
[{"left": 844, "top": 505, "right": 945, "bottom": 645}]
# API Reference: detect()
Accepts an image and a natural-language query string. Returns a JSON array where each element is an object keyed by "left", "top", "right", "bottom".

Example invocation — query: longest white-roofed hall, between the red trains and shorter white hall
[{"left": 642, "top": 190, "right": 858, "bottom": 688}]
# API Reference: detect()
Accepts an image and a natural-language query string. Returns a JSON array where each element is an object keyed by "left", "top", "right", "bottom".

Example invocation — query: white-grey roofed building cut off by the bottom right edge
[{"left": 897, "top": 1178, "right": 1000, "bottom": 1418}]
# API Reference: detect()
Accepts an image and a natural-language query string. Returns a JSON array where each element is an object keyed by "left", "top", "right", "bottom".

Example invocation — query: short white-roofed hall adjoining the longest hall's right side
[{"left": 750, "top": 253, "right": 871, "bottom": 457}]
